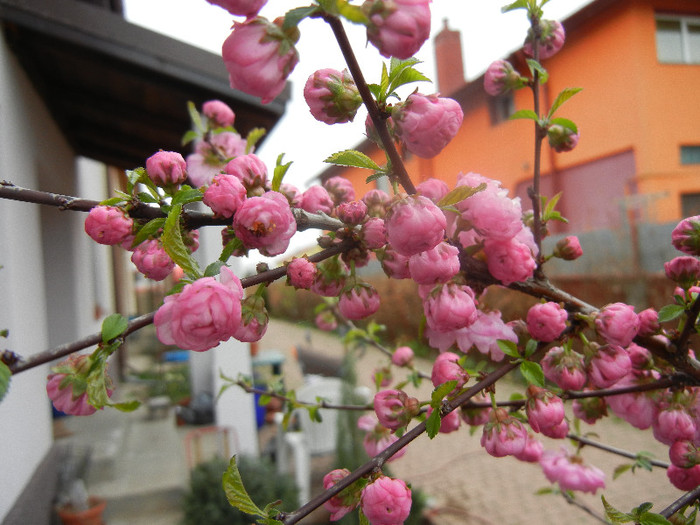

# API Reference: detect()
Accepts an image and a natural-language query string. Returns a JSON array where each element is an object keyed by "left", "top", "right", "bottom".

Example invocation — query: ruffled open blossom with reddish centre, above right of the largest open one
[{"left": 233, "top": 191, "right": 297, "bottom": 256}]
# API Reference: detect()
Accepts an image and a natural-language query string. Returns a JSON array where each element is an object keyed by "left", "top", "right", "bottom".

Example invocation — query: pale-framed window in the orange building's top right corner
[{"left": 656, "top": 15, "right": 700, "bottom": 64}]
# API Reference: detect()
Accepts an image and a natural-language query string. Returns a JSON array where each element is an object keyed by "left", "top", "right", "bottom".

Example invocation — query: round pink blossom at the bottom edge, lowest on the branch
[{"left": 360, "top": 476, "right": 411, "bottom": 525}]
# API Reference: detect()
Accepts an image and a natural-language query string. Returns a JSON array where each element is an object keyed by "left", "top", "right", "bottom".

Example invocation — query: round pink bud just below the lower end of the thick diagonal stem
[{"left": 385, "top": 196, "right": 447, "bottom": 257}]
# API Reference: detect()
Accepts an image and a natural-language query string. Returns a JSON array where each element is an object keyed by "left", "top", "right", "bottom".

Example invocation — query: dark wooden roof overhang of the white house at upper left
[{"left": 0, "top": 0, "right": 289, "bottom": 168}]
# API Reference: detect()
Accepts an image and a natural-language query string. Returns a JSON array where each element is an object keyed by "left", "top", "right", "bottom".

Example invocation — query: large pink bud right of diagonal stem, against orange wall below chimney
[{"left": 392, "top": 93, "right": 464, "bottom": 159}]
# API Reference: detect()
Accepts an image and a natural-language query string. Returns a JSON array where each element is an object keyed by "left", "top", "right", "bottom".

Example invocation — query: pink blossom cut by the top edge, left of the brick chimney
[{"left": 363, "top": 0, "right": 430, "bottom": 59}]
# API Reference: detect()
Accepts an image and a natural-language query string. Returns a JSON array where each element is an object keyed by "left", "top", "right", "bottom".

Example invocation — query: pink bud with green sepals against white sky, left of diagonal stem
[{"left": 304, "top": 68, "right": 362, "bottom": 124}]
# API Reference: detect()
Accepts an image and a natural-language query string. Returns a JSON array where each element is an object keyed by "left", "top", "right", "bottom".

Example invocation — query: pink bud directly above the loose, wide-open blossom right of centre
[{"left": 423, "top": 284, "right": 477, "bottom": 332}]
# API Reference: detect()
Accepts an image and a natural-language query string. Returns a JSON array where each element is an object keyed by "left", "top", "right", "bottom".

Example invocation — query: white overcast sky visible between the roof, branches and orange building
[{"left": 125, "top": 0, "right": 591, "bottom": 189}]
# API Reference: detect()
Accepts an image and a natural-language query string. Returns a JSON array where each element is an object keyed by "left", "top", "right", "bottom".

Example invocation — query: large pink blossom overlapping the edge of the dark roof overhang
[{"left": 221, "top": 17, "right": 299, "bottom": 104}]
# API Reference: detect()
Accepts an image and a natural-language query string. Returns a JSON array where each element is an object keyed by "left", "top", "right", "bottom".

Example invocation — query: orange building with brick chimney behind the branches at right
[{"left": 321, "top": 0, "right": 700, "bottom": 231}]
